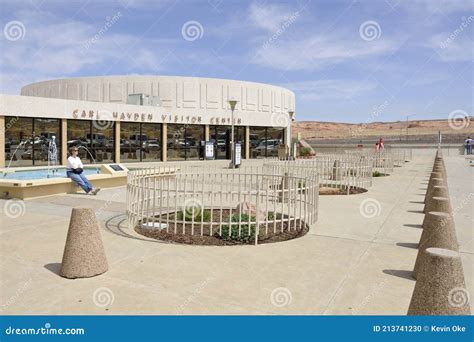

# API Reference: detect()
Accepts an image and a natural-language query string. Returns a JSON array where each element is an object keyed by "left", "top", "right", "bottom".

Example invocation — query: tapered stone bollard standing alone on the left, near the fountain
[{"left": 59, "top": 207, "right": 108, "bottom": 278}]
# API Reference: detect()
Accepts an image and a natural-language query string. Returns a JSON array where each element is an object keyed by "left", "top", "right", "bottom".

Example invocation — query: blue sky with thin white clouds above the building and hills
[{"left": 0, "top": 0, "right": 474, "bottom": 122}]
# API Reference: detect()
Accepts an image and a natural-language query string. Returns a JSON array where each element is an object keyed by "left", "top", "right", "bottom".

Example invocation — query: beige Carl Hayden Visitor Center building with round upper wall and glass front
[{"left": 0, "top": 76, "right": 295, "bottom": 167}]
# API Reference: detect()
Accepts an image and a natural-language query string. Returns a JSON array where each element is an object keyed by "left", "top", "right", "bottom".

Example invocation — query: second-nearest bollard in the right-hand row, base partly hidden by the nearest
[{"left": 413, "top": 211, "right": 459, "bottom": 279}]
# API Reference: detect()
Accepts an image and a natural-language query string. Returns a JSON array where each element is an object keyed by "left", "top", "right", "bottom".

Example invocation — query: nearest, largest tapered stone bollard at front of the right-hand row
[{"left": 408, "top": 248, "right": 470, "bottom": 315}]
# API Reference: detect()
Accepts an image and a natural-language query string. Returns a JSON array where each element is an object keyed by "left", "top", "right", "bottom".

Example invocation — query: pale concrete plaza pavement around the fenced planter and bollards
[{"left": 0, "top": 153, "right": 474, "bottom": 315}]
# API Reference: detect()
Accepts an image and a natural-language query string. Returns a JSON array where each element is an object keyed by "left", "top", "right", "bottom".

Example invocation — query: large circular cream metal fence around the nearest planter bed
[{"left": 127, "top": 166, "right": 319, "bottom": 244}]
